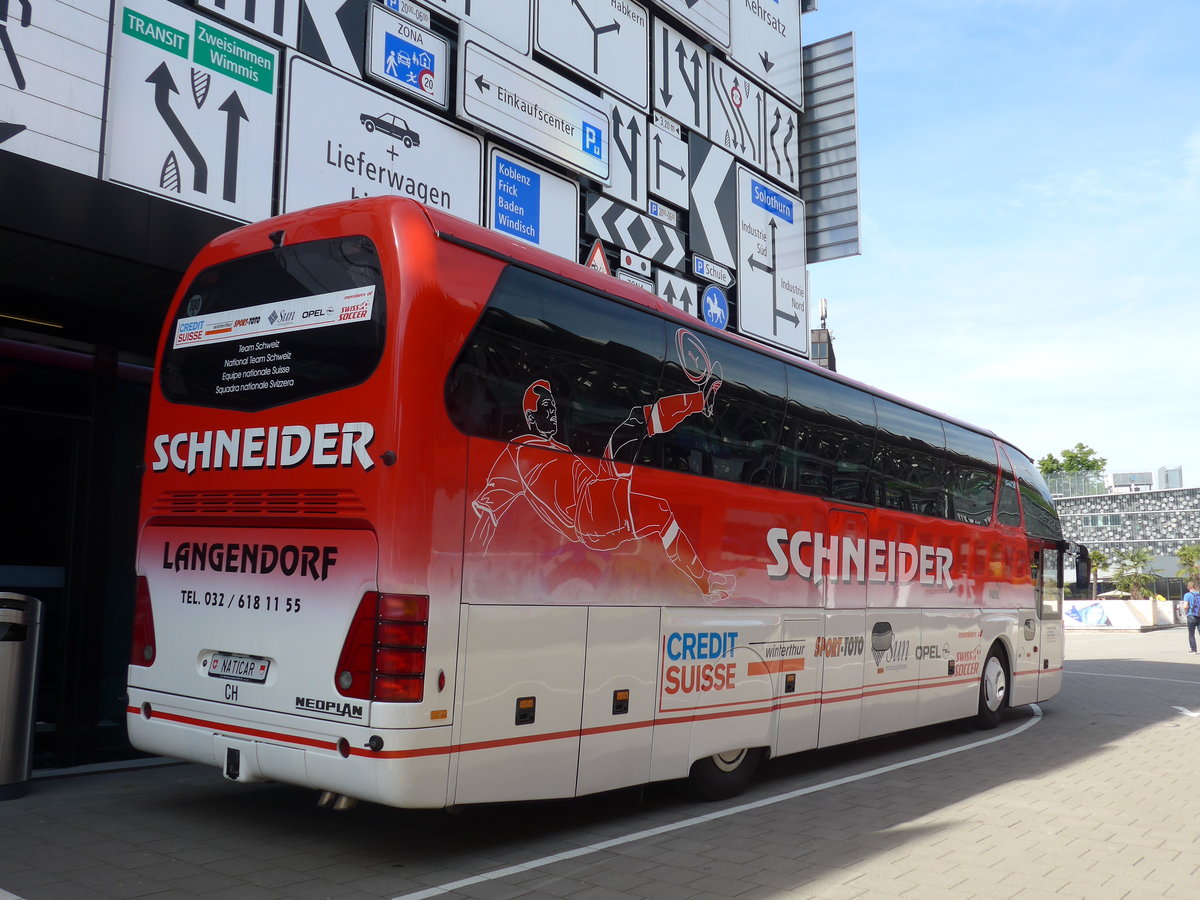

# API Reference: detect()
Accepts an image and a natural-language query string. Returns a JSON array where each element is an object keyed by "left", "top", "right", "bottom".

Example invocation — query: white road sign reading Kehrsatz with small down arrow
[{"left": 730, "top": 0, "right": 804, "bottom": 98}]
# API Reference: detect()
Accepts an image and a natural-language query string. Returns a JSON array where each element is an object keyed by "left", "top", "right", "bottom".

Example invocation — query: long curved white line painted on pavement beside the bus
[{"left": 394, "top": 703, "right": 1042, "bottom": 900}]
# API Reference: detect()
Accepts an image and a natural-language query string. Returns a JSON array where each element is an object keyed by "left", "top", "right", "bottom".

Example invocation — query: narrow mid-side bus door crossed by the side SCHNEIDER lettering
[{"left": 812, "top": 509, "right": 870, "bottom": 746}]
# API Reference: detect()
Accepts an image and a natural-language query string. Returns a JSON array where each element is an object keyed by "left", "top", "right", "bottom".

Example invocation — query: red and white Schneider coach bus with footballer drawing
[{"left": 127, "top": 198, "right": 1086, "bottom": 808}]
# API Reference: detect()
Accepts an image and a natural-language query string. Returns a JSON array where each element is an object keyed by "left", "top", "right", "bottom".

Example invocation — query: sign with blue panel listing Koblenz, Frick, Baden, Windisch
[{"left": 487, "top": 146, "right": 580, "bottom": 262}]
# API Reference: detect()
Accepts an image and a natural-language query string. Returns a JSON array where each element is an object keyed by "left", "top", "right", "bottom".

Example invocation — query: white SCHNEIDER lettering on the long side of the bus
[{"left": 767, "top": 528, "right": 954, "bottom": 590}]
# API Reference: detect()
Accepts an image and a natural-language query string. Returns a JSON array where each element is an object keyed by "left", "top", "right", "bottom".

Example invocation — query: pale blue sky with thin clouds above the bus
[{"left": 802, "top": 0, "right": 1200, "bottom": 487}]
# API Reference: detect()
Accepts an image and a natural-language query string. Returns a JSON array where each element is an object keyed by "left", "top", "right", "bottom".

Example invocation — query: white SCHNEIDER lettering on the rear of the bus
[{"left": 150, "top": 422, "right": 374, "bottom": 474}]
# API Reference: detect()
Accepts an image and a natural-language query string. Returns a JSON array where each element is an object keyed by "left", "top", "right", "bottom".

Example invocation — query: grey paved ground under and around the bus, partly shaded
[{"left": 0, "top": 630, "right": 1200, "bottom": 900}]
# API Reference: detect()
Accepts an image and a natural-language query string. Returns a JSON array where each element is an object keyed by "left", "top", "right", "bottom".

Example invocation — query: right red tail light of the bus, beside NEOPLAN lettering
[{"left": 336, "top": 590, "right": 430, "bottom": 703}]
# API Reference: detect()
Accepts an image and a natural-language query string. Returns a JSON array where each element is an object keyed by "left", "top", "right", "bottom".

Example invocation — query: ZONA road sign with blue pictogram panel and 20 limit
[{"left": 366, "top": 4, "right": 450, "bottom": 109}]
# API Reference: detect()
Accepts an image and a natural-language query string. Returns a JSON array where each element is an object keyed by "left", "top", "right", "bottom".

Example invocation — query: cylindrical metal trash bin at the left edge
[{"left": 0, "top": 593, "right": 42, "bottom": 800}]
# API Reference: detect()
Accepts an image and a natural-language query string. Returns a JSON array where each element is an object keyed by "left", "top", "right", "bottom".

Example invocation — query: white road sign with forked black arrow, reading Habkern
[{"left": 534, "top": 0, "right": 650, "bottom": 113}]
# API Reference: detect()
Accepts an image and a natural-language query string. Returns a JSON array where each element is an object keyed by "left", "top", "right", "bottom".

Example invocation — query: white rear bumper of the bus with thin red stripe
[{"left": 126, "top": 686, "right": 450, "bottom": 809}]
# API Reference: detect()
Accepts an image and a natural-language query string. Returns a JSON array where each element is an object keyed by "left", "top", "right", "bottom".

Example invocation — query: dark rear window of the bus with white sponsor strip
[{"left": 161, "top": 236, "right": 386, "bottom": 412}]
